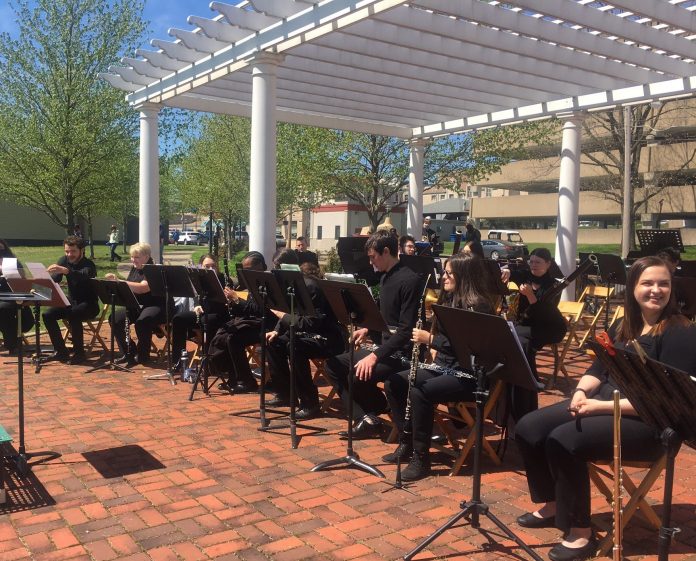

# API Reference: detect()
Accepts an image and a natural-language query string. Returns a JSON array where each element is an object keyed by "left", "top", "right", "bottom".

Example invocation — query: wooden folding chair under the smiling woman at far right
[{"left": 588, "top": 455, "right": 667, "bottom": 556}]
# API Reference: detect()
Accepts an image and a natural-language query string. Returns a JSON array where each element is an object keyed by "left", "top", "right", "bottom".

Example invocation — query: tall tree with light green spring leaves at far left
[{"left": 0, "top": 0, "right": 145, "bottom": 232}]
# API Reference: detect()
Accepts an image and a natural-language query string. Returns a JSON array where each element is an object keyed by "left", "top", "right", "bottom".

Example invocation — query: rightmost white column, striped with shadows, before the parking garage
[{"left": 556, "top": 113, "right": 584, "bottom": 300}]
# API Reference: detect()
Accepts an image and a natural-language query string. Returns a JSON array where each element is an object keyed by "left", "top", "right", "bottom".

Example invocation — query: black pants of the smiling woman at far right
[{"left": 515, "top": 400, "right": 663, "bottom": 532}]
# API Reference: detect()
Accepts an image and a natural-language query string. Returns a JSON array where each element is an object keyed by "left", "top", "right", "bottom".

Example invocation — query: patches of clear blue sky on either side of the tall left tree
[{"left": 0, "top": 0, "right": 212, "bottom": 49}]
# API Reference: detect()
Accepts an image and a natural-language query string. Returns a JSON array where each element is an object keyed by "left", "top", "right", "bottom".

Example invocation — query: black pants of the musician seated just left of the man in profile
[{"left": 266, "top": 333, "right": 344, "bottom": 408}]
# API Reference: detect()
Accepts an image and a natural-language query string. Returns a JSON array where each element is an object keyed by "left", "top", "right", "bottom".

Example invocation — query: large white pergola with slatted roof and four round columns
[{"left": 102, "top": 0, "right": 696, "bottom": 274}]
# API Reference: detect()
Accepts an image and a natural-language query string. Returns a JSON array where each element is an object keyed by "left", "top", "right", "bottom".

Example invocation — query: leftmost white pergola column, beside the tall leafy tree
[{"left": 137, "top": 103, "right": 160, "bottom": 263}]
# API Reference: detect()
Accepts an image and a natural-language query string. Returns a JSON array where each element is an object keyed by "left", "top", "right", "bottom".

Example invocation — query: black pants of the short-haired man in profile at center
[{"left": 326, "top": 349, "right": 404, "bottom": 420}]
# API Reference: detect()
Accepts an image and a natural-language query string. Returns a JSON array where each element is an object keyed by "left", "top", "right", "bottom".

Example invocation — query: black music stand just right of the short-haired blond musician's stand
[{"left": 143, "top": 265, "right": 196, "bottom": 386}]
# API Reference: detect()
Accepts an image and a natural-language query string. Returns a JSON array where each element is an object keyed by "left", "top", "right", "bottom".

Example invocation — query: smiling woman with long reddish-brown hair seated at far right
[{"left": 515, "top": 257, "right": 696, "bottom": 561}]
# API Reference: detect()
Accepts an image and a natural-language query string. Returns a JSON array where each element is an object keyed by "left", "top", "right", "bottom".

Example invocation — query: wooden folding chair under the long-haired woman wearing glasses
[{"left": 433, "top": 380, "right": 505, "bottom": 475}]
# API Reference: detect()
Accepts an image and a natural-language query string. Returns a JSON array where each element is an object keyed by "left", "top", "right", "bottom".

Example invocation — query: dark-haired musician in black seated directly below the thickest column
[{"left": 209, "top": 251, "right": 266, "bottom": 393}]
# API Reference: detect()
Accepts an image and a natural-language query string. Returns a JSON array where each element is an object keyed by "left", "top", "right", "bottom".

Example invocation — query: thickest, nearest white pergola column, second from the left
[{"left": 248, "top": 53, "right": 283, "bottom": 263}]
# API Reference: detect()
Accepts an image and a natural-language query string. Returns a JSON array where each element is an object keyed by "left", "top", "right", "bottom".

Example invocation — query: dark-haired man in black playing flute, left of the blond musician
[{"left": 42, "top": 236, "right": 99, "bottom": 364}]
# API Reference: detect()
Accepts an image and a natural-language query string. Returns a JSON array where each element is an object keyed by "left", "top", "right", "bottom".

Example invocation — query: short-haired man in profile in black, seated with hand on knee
[{"left": 326, "top": 233, "right": 423, "bottom": 439}]
